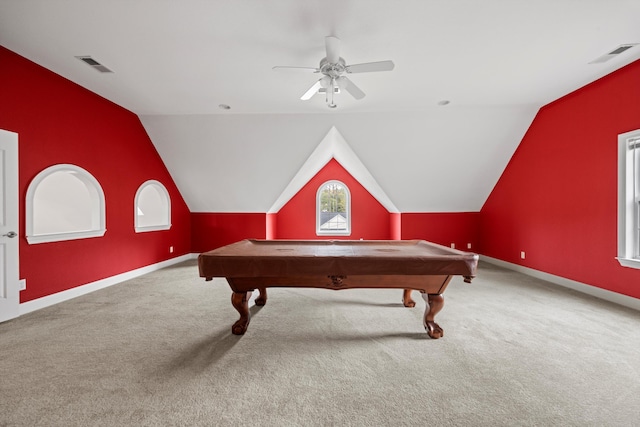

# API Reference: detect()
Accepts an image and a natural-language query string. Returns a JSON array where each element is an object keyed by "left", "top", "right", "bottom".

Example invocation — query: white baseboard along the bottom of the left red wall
[{"left": 18, "top": 254, "right": 198, "bottom": 316}]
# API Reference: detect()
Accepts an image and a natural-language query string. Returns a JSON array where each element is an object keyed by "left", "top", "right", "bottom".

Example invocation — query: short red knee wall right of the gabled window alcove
[{"left": 402, "top": 212, "right": 480, "bottom": 252}]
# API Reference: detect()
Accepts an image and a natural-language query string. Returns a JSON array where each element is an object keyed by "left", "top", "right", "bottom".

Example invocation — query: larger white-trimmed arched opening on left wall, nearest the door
[{"left": 26, "top": 164, "right": 106, "bottom": 244}]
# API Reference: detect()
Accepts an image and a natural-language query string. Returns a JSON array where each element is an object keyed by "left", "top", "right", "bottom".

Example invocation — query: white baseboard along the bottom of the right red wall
[{"left": 480, "top": 255, "right": 640, "bottom": 311}]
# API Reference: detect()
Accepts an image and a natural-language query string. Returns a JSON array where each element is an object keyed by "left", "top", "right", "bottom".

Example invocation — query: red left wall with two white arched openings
[{"left": 0, "top": 47, "right": 191, "bottom": 302}]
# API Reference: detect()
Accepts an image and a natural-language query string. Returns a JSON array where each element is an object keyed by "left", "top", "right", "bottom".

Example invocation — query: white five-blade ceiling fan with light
[{"left": 273, "top": 36, "right": 394, "bottom": 108}]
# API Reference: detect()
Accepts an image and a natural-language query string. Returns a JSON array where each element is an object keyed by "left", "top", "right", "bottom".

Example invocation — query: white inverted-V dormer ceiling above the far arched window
[{"left": 267, "top": 126, "right": 400, "bottom": 214}]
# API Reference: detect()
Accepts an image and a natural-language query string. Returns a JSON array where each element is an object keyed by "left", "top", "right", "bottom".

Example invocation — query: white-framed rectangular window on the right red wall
[{"left": 617, "top": 129, "right": 640, "bottom": 268}]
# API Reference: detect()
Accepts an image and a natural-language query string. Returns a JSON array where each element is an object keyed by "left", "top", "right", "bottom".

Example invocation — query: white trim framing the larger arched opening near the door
[{"left": 25, "top": 164, "right": 107, "bottom": 244}]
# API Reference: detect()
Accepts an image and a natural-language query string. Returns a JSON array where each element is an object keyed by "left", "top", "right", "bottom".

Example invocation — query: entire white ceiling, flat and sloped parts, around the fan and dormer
[{"left": 0, "top": 0, "right": 640, "bottom": 212}]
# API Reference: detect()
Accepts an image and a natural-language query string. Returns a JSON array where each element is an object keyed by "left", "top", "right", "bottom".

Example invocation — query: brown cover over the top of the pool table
[{"left": 198, "top": 239, "right": 478, "bottom": 278}]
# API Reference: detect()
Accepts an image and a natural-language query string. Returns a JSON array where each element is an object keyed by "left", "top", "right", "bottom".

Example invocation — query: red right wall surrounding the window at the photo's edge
[{"left": 480, "top": 61, "right": 640, "bottom": 298}]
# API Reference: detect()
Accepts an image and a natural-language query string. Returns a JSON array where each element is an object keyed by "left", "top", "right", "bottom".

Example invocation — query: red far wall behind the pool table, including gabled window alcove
[{"left": 191, "top": 159, "right": 479, "bottom": 252}]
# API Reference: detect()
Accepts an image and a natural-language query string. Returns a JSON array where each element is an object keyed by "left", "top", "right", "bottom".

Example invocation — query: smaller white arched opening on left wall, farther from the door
[{"left": 134, "top": 180, "right": 171, "bottom": 233}]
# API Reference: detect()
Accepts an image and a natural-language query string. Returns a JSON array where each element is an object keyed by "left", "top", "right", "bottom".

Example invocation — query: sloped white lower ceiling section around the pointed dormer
[{"left": 141, "top": 105, "right": 538, "bottom": 212}]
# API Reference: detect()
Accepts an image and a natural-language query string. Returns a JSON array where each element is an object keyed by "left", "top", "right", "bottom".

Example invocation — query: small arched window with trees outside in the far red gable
[{"left": 316, "top": 181, "right": 351, "bottom": 236}]
